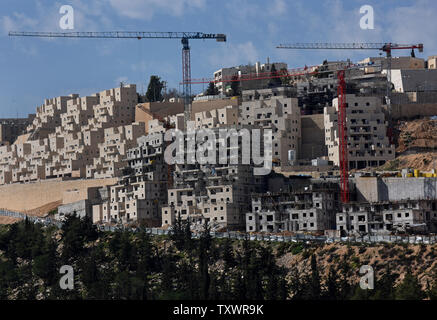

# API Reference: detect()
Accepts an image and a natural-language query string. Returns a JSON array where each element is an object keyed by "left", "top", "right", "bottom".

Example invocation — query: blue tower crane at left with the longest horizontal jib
[{"left": 9, "top": 31, "right": 226, "bottom": 126}]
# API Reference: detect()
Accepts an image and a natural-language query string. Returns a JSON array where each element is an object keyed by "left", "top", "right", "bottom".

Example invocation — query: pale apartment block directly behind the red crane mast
[{"left": 324, "top": 94, "right": 395, "bottom": 169}]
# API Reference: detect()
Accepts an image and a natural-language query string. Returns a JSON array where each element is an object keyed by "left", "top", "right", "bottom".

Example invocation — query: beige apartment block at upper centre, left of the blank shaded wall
[{"left": 239, "top": 87, "right": 301, "bottom": 165}]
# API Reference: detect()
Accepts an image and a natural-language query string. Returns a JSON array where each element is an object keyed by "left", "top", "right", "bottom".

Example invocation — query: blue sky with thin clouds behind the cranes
[{"left": 0, "top": 0, "right": 437, "bottom": 118}]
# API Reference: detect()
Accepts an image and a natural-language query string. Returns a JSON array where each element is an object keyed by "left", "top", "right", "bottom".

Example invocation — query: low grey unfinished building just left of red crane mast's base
[{"left": 246, "top": 180, "right": 339, "bottom": 233}]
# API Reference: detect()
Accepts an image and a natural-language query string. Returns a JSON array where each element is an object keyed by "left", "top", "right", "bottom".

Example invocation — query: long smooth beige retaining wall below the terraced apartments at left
[{"left": 0, "top": 178, "right": 118, "bottom": 211}]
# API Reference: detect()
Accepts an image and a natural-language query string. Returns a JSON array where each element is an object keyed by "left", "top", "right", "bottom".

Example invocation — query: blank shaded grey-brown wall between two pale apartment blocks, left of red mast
[{"left": 299, "top": 114, "right": 328, "bottom": 159}]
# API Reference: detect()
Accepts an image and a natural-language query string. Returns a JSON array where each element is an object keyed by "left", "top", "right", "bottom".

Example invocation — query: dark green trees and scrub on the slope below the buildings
[{"left": 0, "top": 215, "right": 437, "bottom": 300}]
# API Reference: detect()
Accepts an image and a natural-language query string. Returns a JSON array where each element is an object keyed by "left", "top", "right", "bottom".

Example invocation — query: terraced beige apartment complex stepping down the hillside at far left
[{"left": 0, "top": 85, "right": 145, "bottom": 184}]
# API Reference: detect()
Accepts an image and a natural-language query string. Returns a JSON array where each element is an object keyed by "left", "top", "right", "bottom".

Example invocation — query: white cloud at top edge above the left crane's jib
[{"left": 109, "top": 0, "right": 206, "bottom": 20}]
